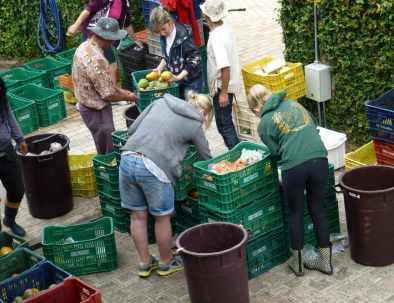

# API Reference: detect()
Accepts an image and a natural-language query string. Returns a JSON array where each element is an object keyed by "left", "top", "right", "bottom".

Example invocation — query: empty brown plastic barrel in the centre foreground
[{"left": 176, "top": 222, "right": 249, "bottom": 303}]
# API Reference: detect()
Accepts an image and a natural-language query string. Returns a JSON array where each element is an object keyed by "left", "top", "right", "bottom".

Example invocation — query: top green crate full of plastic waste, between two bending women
[{"left": 194, "top": 141, "right": 279, "bottom": 211}]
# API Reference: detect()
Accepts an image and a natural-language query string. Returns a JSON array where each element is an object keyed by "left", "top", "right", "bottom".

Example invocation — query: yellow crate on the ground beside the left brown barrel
[{"left": 68, "top": 154, "right": 97, "bottom": 197}]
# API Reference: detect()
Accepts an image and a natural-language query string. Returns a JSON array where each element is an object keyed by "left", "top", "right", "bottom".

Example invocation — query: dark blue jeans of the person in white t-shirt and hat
[{"left": 213, "top": 88, "right": 239, "bottom": 149}]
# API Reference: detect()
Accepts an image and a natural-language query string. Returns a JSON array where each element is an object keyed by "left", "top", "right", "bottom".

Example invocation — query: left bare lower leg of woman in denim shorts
[{"left": 130, "top": 210, "right": 150, "bottom": 264}]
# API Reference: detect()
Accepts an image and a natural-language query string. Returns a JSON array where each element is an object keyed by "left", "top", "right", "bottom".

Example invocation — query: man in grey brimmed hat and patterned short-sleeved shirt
[{"left": 72, "top": 17, "right": 138, "bottom": 154}]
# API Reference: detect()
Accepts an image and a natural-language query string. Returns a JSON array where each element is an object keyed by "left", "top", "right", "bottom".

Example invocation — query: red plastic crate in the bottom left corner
[{"left": 23, "top": 277, "right": 101, "bottom": 303}]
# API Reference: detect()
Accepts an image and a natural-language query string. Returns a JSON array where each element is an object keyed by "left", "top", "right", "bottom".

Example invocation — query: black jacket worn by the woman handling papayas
[{"left": 160, "top": 22, "right": 202, "bottom": 83}]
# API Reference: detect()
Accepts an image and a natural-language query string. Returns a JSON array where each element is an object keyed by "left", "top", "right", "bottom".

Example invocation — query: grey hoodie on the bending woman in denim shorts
[{"left": 122, "top": 94, "right": 211, "bottom": 184}]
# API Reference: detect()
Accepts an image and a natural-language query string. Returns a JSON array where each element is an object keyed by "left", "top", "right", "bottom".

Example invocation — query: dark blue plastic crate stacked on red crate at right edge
[{"left": 365, "top": 88, "right": 394, "bottom": 143}]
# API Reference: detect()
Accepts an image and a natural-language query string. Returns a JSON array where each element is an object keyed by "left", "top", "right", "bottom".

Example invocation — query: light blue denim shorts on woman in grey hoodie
[{"left": 119, "top": 155, "right": 174, "bottom": 216}]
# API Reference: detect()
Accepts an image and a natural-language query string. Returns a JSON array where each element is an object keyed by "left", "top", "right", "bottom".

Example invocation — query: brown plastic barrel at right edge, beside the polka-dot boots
[{"left": 339, "top": 165, "right": 394, "bottom": 266}]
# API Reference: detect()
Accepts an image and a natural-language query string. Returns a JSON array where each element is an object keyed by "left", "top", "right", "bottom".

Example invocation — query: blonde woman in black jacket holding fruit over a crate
[{"left": 149, "top": 6, "right": 203, "bottom": 100}]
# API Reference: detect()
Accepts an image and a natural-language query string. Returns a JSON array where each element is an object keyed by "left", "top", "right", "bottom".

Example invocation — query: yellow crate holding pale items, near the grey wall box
[{"left": 242, "top": 57, "right": 306, "bottom": 100}]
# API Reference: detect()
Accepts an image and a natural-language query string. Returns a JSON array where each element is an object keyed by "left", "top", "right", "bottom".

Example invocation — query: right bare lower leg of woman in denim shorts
[{"left": 155, "top": 215, "right": 172, "bottom": 264}]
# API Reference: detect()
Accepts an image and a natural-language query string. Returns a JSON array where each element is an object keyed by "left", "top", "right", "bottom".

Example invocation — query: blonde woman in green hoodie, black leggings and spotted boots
[{"left": 247, "top": 84, "right": 333, "bottom": 276}]
